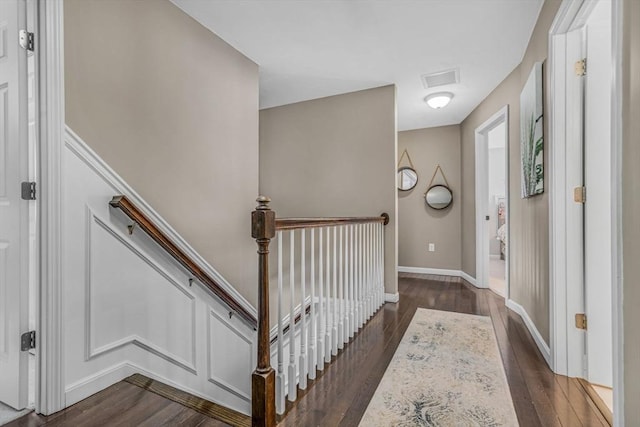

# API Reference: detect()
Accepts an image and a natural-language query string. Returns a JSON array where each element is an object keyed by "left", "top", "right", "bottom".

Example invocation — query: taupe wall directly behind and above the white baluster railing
[{"left": 260, "top": 86, "right": 398, "bottom": 293}]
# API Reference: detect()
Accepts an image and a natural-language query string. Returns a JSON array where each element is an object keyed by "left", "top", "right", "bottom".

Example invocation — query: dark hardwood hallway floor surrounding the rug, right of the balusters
[{"left": 280, "top": 275, "right": 608, "bottom": 427}]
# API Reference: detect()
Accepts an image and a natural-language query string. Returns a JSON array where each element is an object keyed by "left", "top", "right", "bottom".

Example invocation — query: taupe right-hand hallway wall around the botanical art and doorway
[{"left": 461, "top": 0, "right": 561, "bottom": 342}]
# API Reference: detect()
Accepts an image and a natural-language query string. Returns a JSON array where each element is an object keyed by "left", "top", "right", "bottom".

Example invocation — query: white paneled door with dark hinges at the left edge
[{"left": 0, "top": 0, "right": 33, "bottom": 409}]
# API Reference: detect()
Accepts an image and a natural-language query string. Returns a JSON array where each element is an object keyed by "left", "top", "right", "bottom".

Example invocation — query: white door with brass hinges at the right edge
[{"left": 584, "top": 0, "right": 613, "bottom": 387}]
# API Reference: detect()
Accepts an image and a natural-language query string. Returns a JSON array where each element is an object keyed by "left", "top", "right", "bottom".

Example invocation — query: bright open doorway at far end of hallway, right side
[{"left": 475, "top": 106, "right": 509, "bottom": 299}]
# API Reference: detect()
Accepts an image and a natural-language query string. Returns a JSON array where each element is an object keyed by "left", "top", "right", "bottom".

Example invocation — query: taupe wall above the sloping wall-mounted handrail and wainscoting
[{"left": 64, "top": 0, "right": 258, "bottom": 305}]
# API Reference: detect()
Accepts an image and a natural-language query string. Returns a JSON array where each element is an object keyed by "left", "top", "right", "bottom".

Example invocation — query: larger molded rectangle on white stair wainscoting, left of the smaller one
[{"left": 85, "top": 208, "right": 196, "bottom": 373}]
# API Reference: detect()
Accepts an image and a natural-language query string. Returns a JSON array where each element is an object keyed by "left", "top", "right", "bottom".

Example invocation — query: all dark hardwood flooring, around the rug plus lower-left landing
[{"left": 9, "top": 275, "right": 608, "bottom": 427}]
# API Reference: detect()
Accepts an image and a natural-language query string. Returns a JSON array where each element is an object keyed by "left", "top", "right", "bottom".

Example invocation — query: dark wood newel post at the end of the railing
[{"left": 251, "top": 196, "right": 276, "bottom": 427}]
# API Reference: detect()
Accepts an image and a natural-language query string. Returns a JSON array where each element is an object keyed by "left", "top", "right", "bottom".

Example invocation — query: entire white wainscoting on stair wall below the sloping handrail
[{"left": 62, "top": 131, "right": 256, "bottom": 414}]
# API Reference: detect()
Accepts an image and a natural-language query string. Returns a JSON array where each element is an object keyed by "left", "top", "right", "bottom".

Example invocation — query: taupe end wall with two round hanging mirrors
[{"left": 398, "top": 125, "right": 462, "bottom": 270}]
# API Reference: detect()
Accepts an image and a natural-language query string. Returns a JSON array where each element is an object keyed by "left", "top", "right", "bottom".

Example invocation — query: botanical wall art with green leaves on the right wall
[{"left": 520, "top": 62, "right": 544, "bottom": 198}]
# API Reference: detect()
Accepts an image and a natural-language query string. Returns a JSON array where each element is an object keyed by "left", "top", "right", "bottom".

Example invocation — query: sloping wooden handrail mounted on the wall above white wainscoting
[{"left": 109, "top": 196, "right": 258, "bottom": 329}]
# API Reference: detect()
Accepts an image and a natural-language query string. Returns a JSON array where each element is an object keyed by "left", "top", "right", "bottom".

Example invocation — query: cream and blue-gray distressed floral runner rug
[{"left": 360, "top": 309, "right": 518, "bottom": 427}]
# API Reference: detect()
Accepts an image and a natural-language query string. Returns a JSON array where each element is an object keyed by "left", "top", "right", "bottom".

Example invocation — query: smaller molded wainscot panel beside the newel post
[{"left": 208, "top": 310, "right": 254, "bottom": 402}]
